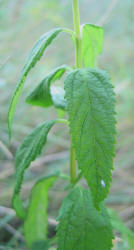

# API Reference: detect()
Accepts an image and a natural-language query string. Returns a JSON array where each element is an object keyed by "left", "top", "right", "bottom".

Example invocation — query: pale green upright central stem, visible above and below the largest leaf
[{"left": 70, "top": 0, "right": 82, "bottom": 184}]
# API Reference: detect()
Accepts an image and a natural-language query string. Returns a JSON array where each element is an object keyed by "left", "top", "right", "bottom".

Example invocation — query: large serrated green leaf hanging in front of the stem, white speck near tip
[{"left": 65, "top": 69, "right": 115, "bottom": 209}]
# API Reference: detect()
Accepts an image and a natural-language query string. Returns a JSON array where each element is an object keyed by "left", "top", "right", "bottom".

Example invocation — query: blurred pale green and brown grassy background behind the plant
[{"left": 0, "top": 0, "right": 134, "bottom": 250}]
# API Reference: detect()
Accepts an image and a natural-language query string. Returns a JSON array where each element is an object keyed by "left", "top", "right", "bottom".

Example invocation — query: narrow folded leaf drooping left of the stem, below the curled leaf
[{"left": 12, "top": 120, "right": 56, "bottom": 218}]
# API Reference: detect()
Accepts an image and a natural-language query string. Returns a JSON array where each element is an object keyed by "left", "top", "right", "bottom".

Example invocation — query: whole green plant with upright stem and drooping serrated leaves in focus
[{"left": 8, "top": 0, "right": 116, "bottom": 250}]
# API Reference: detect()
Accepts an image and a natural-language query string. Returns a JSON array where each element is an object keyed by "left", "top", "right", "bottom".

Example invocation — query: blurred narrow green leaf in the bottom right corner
[{"left": 108, "top": 209, "right": 134, "bottom": 250}]
